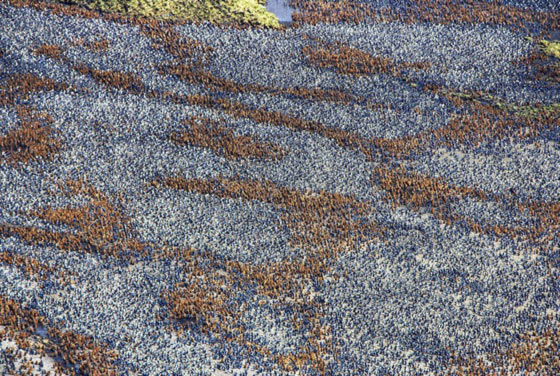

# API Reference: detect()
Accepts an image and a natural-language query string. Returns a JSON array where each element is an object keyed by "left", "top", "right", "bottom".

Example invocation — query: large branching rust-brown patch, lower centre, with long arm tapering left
[{"left": 151, "top": 176, "right": 387, "bottom": 374}]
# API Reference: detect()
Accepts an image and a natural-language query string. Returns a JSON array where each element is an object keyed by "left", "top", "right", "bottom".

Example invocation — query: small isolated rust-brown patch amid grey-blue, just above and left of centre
[{"left": 171, "top": 117, "right": 287, "bottom": 160}]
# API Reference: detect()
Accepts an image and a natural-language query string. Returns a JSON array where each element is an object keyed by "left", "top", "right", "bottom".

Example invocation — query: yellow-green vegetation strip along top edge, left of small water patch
[{"left": 55, "top": 0, "right": 280, "bottom": 28}]
